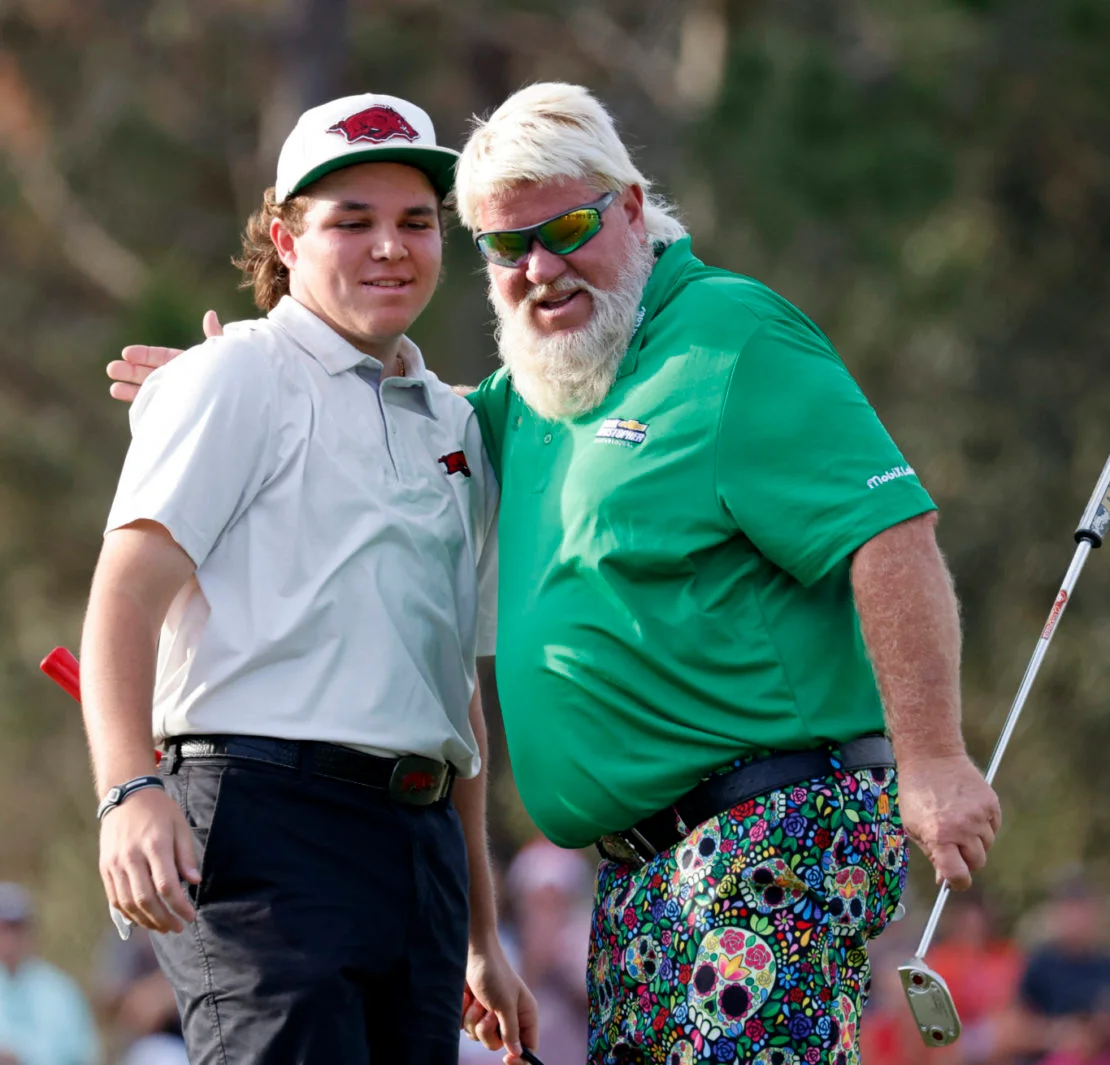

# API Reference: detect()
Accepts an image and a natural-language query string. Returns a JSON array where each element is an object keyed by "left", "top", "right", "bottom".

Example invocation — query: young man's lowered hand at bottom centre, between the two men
[{"left": 463, "top": 943, "right": 538, "bottom": 1065}]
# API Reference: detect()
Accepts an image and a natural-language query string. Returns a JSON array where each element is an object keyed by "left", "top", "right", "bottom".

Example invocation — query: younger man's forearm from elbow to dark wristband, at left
[{"left": 81, "top": 585, "right": 161, "bottom": 795}]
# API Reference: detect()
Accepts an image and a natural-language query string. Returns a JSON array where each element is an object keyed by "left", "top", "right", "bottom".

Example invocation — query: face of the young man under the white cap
[{"left": 271, "top": 163, "right": 443, "bottom": 362}]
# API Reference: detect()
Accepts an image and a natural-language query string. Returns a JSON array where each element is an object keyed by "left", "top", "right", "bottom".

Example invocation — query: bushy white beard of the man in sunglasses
[{"left": 490, "top": 233, "right": 655, "bottom": 421}]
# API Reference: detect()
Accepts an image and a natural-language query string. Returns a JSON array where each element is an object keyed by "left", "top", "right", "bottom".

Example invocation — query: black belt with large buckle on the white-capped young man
[{"left": 165, "top": 736, "right": 455, "bottom": 806}]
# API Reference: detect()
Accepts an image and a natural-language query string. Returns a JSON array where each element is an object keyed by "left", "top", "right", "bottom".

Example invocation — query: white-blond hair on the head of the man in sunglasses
[{"left": 455, "top": 81, "right": 686, "bottom": 244}]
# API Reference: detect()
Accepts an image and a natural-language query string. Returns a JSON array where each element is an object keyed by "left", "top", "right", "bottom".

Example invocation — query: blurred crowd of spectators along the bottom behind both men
[{"left": 0, "top": 861, "right": 1110, "bottom": 1065}]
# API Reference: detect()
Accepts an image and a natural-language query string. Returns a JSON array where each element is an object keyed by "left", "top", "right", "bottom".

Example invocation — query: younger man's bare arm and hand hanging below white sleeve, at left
[{"left": 81, "top": 521, "right": 200, "bottom": 932}]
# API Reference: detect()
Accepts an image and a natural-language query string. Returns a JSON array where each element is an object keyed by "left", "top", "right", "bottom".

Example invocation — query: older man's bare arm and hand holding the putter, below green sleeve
[{"left": 851, "top": 512, "right": 1001, "bottom": 891}]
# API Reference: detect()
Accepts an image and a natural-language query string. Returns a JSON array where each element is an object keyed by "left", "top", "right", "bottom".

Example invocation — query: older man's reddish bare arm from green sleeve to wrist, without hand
[{"left": 851, "top": 514, "right": 963, "bottom": 762}]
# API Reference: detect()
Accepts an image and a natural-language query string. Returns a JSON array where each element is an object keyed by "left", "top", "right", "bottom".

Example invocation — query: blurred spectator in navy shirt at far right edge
[{"left": 1016, "top": 875, "right": 1110, "bottom": 1065}]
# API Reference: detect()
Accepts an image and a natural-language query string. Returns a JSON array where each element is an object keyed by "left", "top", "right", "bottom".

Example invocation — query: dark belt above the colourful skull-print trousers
[{"left": 597, "top": 735, "right": 895, "bottom": 867}]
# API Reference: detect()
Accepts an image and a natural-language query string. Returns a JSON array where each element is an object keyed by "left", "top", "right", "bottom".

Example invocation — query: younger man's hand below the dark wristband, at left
[{"left": 100, "top": 787, "right": 201, "bottom": 932}]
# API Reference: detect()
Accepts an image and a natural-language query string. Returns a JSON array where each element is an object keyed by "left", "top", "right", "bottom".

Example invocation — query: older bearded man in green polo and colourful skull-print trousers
[{"left": 110, "top": 84, "right": 1000, "bottom": 1065}]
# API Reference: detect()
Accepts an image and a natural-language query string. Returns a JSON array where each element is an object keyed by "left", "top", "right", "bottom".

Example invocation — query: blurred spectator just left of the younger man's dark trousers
[{"left": 97, "top": 926, "right": 189, "bottom": 1065}]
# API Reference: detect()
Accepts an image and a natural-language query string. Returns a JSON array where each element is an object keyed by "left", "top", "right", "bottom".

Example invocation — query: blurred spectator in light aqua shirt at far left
[{"left": 0, "top": 883, "right": 100, "bottom": 1065}]
